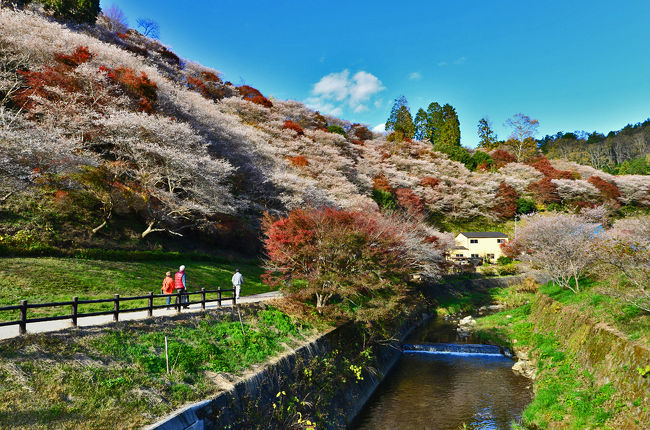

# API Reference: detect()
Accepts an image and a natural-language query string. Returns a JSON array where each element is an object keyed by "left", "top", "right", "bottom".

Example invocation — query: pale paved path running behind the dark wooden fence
[{"left": 0, "top": 291, "right": 280, "bottom": 339}]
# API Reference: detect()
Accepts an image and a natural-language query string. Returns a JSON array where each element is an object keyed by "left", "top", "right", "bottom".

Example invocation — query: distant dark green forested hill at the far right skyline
[{"left": 539, "top": 120, "right": 650, "bottom": 175}]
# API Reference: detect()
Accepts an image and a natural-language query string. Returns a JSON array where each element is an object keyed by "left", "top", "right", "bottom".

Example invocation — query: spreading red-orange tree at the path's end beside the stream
[{"left": 263, "top": 208, "right": 444, "bottom": 317}]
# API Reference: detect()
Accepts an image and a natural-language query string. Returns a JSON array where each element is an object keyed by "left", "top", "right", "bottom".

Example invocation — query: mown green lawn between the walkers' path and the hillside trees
[{"left": 0, "top": 257, "right": 270, "bottom": 321}]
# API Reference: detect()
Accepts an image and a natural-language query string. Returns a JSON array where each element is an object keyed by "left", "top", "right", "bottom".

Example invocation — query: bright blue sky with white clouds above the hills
[{"left": 101, "top": 0, "right": 650, "bottom": 147}]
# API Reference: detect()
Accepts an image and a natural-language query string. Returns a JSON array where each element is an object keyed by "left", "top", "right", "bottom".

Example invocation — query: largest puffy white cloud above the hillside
[{"left": 307, "top": 69, "right": 385, "bottom": 115}]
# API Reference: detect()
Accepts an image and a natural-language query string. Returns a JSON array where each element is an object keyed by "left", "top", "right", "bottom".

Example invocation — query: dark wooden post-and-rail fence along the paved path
[{"left": 0, "top": 288, "right": 237, "bottom": 335}]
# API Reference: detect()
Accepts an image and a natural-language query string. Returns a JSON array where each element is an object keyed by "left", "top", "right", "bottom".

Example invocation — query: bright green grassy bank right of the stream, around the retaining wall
[{"left": 470, "top": 283, "right": 648, "bottom": 429}]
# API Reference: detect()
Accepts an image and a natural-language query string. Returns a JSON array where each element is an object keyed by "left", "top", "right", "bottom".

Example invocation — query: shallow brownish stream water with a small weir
[{"left": 352, "top": 321, "right": 531, "bottom": 430}]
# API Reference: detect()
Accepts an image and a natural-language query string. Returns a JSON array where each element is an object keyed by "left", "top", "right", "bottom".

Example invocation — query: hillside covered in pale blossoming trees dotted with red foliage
[{"left": 0, "top": 8, "right": 650, "bottom": 253}]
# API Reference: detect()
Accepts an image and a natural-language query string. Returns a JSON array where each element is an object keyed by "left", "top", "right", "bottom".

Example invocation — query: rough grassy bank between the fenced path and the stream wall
[{"left": 0, "top": 307, "right": 313, "bottom": 429}]
